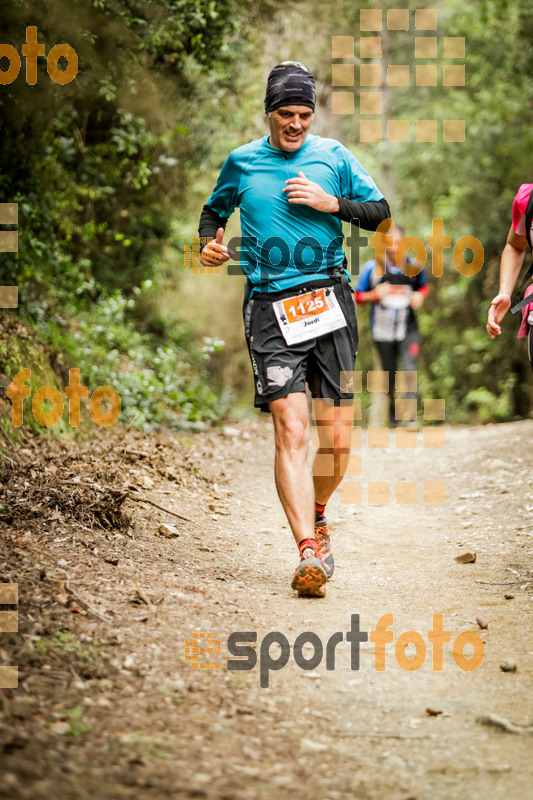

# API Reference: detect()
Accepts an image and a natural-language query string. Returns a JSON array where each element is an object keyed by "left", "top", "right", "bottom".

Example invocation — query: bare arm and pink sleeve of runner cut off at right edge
[{"left": 487, "top": 183, "right": 533, "bottom": 339}]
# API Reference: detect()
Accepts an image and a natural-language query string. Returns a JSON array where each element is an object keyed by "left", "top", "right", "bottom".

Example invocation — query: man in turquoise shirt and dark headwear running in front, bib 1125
[{"left": 199, "top": 62, "right": 390, "bottom": 597}]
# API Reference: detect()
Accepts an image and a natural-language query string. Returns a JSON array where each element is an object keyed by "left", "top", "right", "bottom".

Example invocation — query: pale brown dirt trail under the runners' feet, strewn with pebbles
[{"left": 0, "top": 420, "right": 533, "bottom": 800}]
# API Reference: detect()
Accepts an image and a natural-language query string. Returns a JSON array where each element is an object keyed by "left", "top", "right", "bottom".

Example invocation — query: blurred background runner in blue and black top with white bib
[{"left": 355, "top": 225, "right": 429, "bottom": 425}]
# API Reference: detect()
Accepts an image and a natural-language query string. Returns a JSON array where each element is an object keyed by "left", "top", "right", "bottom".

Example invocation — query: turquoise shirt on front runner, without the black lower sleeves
[{"left": 207, "top": 134, "right": 383, "bottom": 292}]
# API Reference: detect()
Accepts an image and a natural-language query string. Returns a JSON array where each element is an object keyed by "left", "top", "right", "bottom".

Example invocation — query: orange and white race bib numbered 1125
[{"left": 272, "top": 286, "right": 346, "bottom": 345}]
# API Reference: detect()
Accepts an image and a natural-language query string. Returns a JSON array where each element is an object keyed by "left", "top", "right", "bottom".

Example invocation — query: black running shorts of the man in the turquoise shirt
[{"left": 243, "top": 276, "right": 357, "bottom": 411}]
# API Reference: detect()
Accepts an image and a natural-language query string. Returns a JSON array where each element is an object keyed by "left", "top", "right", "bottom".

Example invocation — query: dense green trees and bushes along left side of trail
[{"left": 0, "top": 0, "right": 274, "bottom": 428}]
